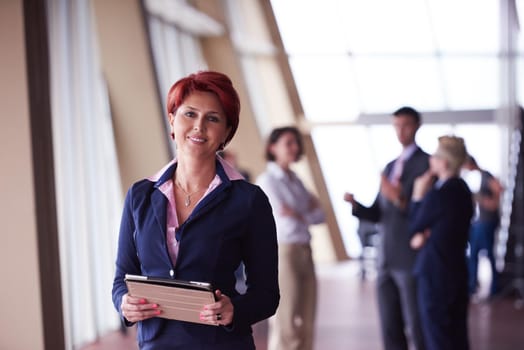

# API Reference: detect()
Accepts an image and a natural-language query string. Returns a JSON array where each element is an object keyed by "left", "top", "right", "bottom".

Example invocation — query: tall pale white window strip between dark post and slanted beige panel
[{"left": 48, "top": 0, "right": 122, "bottom": 349}]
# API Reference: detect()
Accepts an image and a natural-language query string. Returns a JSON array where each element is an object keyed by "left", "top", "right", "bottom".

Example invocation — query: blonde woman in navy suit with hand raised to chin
[{"left": 410, "top": 136, "right": 473, "bottom": 350}]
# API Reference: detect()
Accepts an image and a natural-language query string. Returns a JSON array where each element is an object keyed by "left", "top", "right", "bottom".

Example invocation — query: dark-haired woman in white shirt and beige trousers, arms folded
[{"left": 257, "top": 127, "right": 324, "bottom": 350}]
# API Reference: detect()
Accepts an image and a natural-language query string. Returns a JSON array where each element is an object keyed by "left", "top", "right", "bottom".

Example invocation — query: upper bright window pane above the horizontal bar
[{"left": 272, "top": 0, "right": 499, "bottom": 117}]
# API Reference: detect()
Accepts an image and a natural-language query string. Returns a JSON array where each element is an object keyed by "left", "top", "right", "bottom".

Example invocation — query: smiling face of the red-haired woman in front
[{"left": 169, "top": 91, "right": 231, "bottom": 158}]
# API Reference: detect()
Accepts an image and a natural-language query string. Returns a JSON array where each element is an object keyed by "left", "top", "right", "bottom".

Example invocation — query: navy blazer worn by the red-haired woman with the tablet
[{"left": 113, "top": 160, "right": 279, "bottom": 349}]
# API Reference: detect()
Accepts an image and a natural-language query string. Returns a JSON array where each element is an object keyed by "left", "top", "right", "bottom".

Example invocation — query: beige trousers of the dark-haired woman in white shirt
[{"left": 268, "top": 244, "right": 317, "bottom": 350}]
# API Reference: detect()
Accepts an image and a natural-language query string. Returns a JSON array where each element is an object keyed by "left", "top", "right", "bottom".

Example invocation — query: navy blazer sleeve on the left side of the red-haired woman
[{"left": 112, "top": 188, "right": 140, "bottom": 326}]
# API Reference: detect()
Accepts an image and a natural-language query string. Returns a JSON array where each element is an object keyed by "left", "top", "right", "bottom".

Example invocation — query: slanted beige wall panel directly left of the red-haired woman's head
[{"left": 92, "top": 0, "right": 170, "bottom": 193}]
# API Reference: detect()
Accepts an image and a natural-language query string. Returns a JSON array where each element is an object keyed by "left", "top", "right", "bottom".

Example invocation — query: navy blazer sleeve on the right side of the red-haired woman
[{"left": 232, "top": 187, "right": 280, "bottom": 324}]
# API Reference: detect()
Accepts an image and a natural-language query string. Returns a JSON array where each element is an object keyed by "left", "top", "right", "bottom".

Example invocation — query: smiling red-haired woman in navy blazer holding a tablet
[{"left": 113, "top": 71, "right": 279, "bottom": 349}]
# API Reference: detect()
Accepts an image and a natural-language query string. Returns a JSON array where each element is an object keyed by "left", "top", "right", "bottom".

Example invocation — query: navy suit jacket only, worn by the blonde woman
[{"left": 409, "top": 177, "right": 474, "bottom": 284}]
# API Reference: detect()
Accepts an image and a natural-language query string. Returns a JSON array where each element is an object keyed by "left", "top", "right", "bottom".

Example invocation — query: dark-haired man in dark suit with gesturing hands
[{"left": 344, "top": 107, "right": 429, "bottom": 350}]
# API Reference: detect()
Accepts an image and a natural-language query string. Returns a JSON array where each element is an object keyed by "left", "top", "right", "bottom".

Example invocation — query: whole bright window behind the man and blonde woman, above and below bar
[{"left": 271, "top": 0, "right": 522, "bottom": 256}]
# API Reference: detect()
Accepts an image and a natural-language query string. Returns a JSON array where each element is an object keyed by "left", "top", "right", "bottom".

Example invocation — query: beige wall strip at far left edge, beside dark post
[{"left": 0, "top": 0, "right": 44, "bottom": 350}]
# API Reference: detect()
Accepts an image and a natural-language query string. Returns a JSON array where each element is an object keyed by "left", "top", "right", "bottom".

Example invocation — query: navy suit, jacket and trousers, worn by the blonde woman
[{"left": 410, "top": 177, "right": 473, "bottom": 350}]
